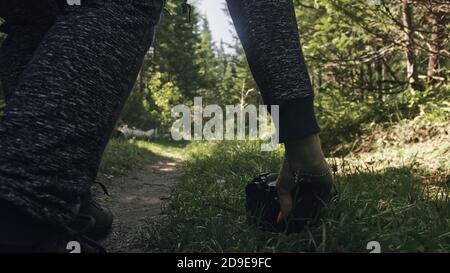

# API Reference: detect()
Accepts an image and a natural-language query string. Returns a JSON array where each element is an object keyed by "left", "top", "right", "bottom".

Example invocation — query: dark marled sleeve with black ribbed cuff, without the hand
[{"left": 227, "top": 0, "right": 320, "bottom": 142}]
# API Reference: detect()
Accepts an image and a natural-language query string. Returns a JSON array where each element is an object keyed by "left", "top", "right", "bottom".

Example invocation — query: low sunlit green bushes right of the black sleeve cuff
[{"left": 316, "top": 86, "right": 450, "bottom": 154}]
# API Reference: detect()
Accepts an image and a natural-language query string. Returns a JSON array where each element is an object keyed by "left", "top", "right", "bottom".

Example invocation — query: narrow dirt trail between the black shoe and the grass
[{"left": 102, "top": 157, "right": 181, "bottom": 253}]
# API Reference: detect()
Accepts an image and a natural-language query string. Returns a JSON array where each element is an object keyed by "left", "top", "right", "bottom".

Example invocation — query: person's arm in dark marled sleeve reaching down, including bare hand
[{"left": 227, "top": 0, "right": 332, "bottom": 218}]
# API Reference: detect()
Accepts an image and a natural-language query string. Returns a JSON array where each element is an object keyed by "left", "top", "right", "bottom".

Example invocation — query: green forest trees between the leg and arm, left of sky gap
[{"left": 121, "top": 1, "right": 225, "bottom": 132}]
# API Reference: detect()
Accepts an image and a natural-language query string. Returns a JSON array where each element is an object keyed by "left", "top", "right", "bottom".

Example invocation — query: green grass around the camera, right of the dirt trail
[{"left": 139, "top": 142, "right": 450, "bottom": 252}]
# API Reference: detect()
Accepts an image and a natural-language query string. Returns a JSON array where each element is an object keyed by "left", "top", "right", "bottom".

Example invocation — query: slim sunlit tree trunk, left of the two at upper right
[{"left": 403, "top": 0, "right": 419, "bottom": 89}]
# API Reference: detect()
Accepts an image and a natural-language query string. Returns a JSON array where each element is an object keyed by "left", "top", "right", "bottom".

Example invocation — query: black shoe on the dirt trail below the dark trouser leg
[{"left": 69, "top": 183, "right": 114, "bottom": 240}]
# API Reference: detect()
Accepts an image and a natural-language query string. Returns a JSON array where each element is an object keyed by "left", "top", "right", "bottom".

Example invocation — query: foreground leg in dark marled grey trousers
[{"left": 0, "top": 0, "right": 163, "bottom": 227}]
